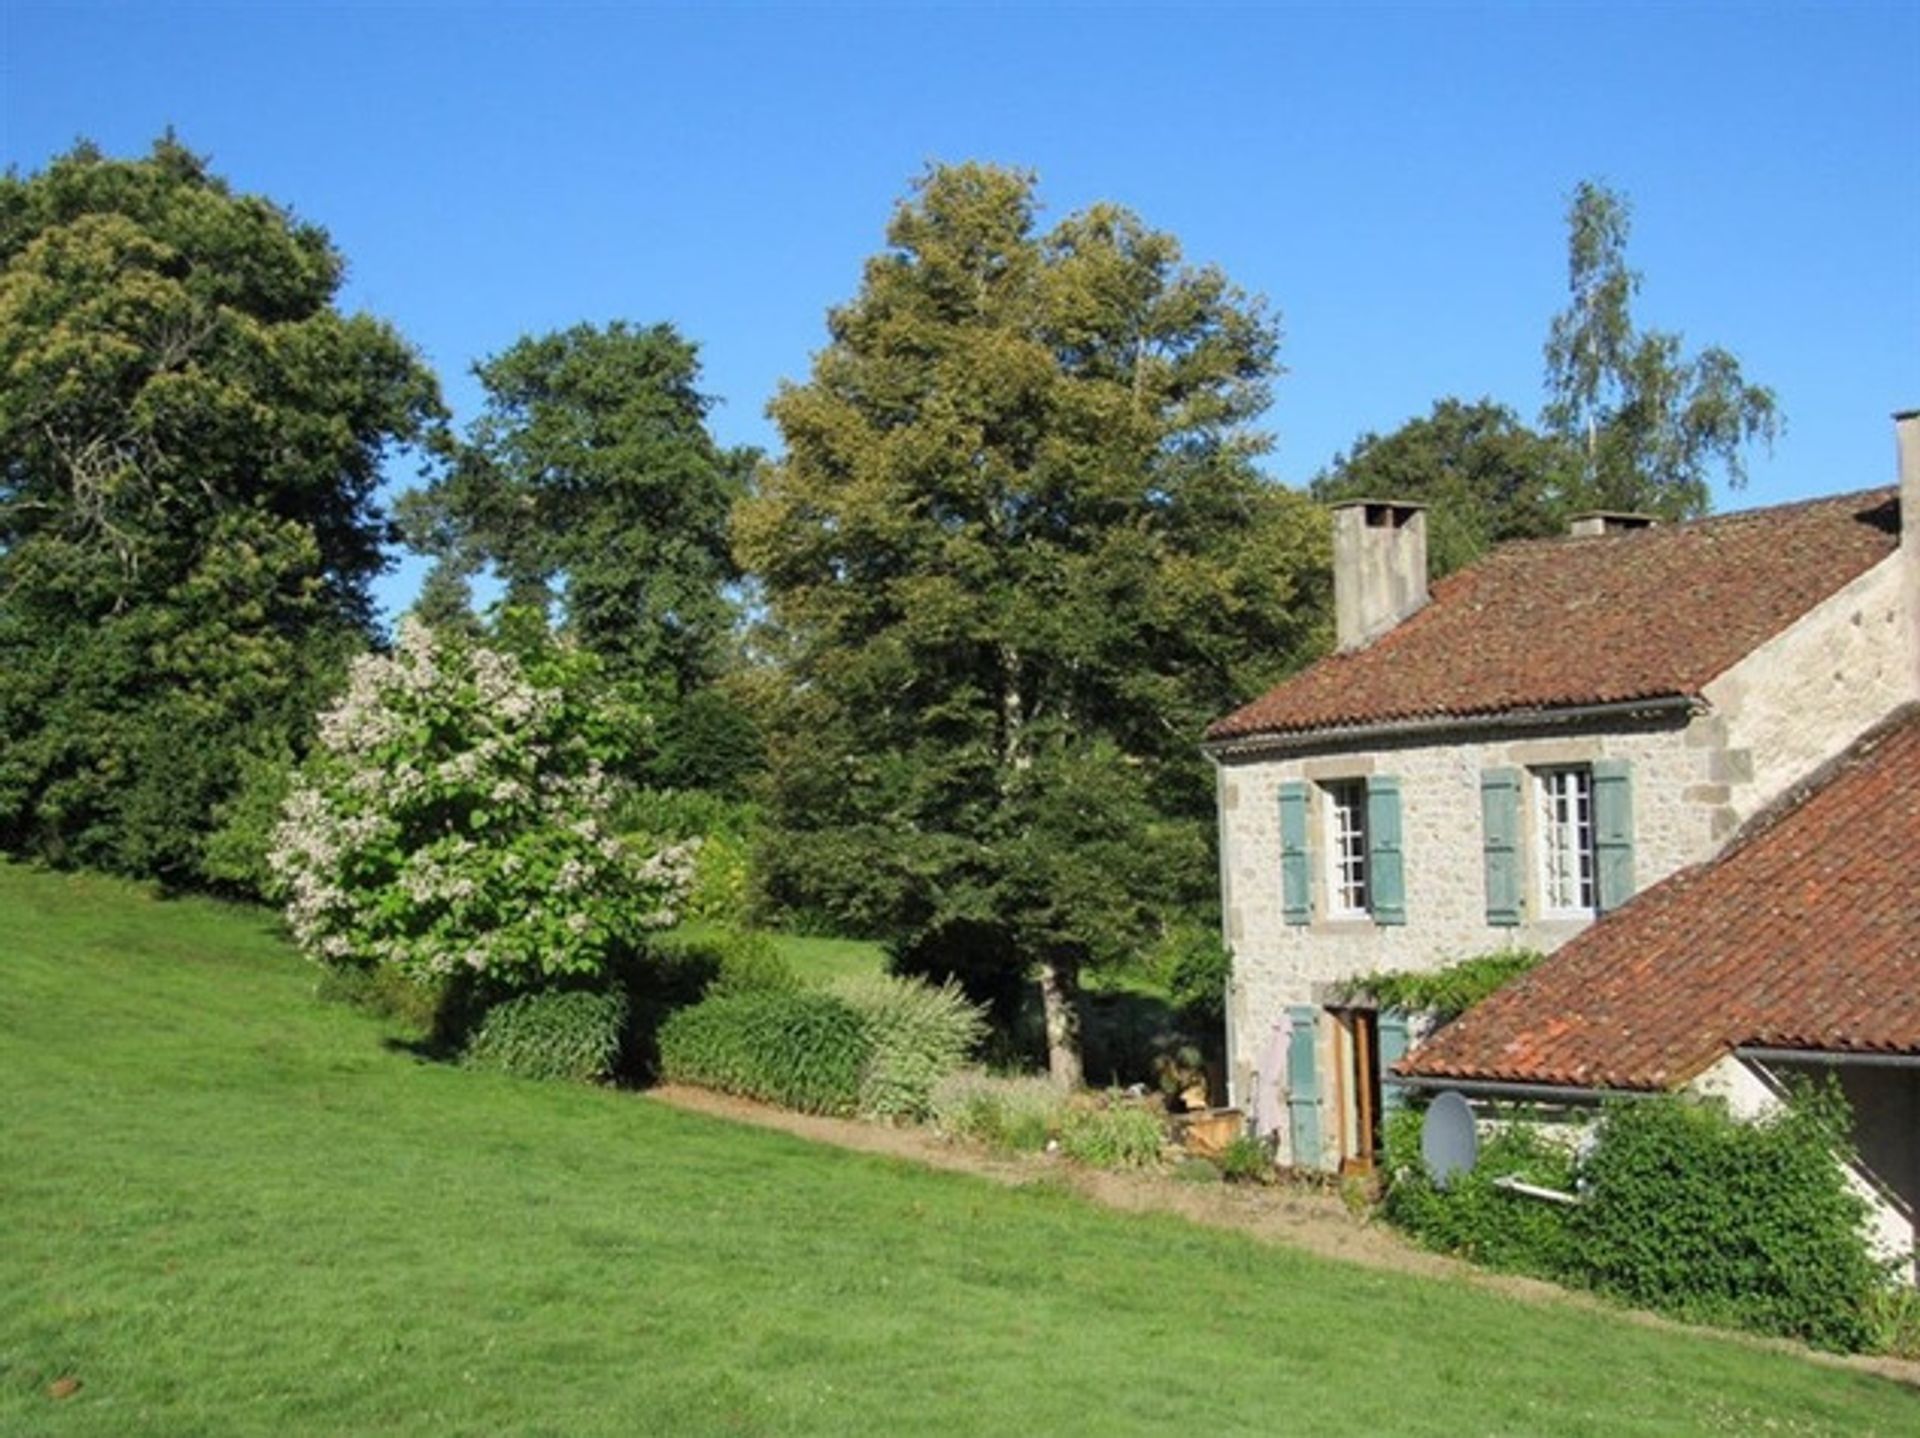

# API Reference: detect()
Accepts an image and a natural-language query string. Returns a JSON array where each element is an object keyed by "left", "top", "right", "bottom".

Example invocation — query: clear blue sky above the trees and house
[{"left": 0, "top": 0, "right": 1920, "bottom": 618}]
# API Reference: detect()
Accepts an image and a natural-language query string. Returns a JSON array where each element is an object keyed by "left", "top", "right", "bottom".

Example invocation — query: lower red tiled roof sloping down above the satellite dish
[{"left": 1400, "top": 705, "right": 1920, "bottom": 1089}]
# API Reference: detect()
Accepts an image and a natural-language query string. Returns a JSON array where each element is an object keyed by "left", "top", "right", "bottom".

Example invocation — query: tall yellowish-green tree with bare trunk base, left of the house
[{"left": 735, "top": 163, "right": 1327, "bottom": 1081}]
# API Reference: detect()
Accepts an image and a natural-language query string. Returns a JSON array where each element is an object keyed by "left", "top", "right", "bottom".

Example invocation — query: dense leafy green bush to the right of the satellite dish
[{"left": 1572, "top": 1085, "right": 1882, "bottom": 1350}]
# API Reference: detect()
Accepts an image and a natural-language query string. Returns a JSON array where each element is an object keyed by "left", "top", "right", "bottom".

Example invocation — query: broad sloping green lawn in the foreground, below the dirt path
[{"left": 0, "top": 866, "right": 1920, "bottom": 1436}]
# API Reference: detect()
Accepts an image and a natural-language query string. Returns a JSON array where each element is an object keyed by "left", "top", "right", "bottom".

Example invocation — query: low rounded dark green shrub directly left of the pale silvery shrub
[{"left": 660, "top": 989, "right": 874, "bottom": 1114}]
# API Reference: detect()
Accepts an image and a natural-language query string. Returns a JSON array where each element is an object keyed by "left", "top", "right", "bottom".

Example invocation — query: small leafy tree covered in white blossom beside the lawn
[{"left": 271, "top": 620, "right": 691, "bottom": 989}]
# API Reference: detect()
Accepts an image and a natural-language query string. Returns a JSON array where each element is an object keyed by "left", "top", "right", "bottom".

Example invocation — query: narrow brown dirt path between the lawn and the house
[{"left": 645, "top": 1085, "right": 1920, "bottom": 1388}]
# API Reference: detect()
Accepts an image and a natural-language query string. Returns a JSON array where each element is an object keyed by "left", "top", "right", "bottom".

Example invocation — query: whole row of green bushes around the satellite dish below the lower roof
[{"left": 1386, "top": 1089, "right": 1899, "bottom": 1350}]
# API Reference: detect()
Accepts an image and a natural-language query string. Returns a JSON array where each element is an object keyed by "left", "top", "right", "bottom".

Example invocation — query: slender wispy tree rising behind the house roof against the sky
[{"left": 1542, "top": 180, "right": 1782, "bottom": 518}]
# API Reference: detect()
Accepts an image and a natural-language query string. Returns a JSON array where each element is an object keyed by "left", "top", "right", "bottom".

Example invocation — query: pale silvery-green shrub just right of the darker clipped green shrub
[{"left": 833, "top": 973, "right": 987, "bottom": 1121}]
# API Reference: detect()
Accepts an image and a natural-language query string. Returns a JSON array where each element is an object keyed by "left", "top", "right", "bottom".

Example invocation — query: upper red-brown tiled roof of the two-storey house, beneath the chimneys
[{"left": 1208, "top": 488, "right": 1899, "bottom": 741}]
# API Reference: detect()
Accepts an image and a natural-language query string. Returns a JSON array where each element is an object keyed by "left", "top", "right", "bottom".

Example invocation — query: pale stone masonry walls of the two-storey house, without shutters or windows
[{"left": 1215, "top": 557, "right": 1916, "bottom": 1163}]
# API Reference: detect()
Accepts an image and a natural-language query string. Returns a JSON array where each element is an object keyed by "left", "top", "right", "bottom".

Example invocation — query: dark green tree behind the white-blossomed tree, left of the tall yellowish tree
[{"left": 401, "top": 321, "right": 753, "bottom": 699}]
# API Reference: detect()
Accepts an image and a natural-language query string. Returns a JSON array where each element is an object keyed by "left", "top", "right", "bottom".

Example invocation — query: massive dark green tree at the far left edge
[{"left": 0, "top": 136, "right": 440, "bottom": 881}]
